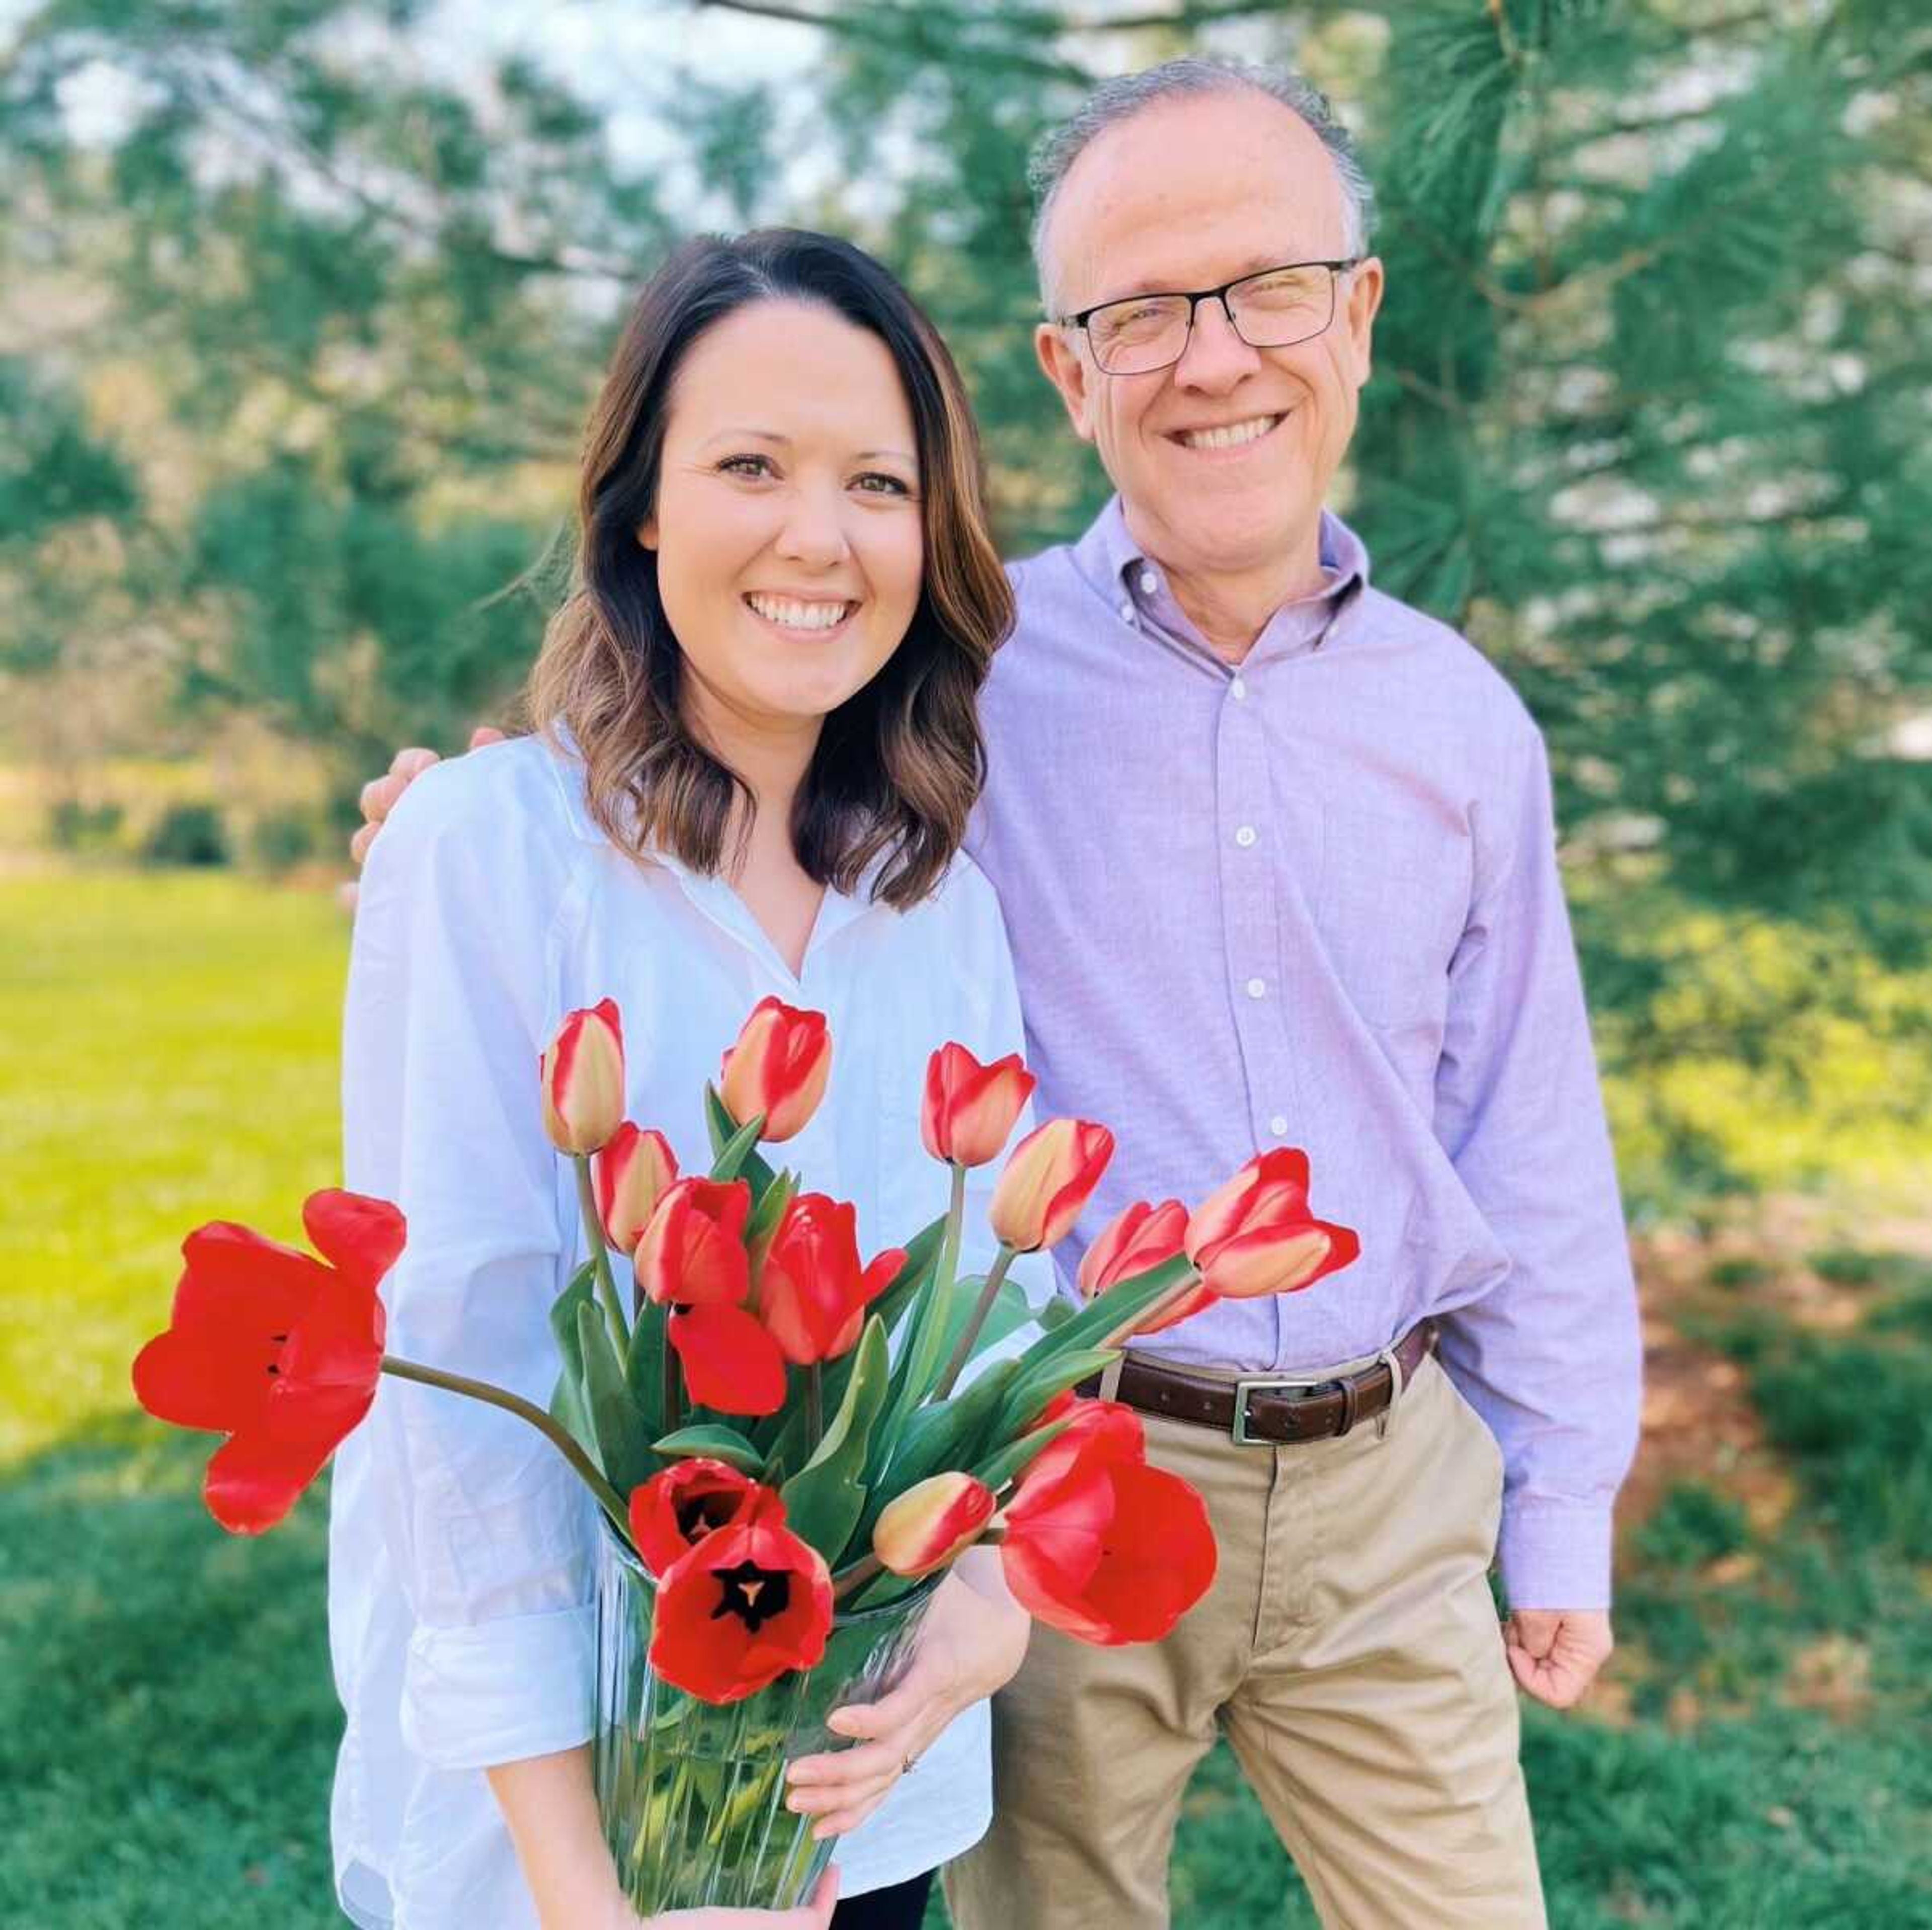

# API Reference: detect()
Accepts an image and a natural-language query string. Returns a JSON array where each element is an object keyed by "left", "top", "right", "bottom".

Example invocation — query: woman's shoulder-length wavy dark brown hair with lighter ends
[{"left": 525, "top": 228, "right": 1012, "bottom": 910}]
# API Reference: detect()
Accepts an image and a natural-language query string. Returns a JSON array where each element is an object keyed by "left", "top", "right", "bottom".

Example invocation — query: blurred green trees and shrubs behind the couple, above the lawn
[{"left": 0, "top": 0, "right": 1932, "bottom": 1209}]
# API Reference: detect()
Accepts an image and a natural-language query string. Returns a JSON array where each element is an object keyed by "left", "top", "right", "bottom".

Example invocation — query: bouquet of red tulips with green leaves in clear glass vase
[{"left": 133, "top": 999, "right": 1356, "bottom": 1911}]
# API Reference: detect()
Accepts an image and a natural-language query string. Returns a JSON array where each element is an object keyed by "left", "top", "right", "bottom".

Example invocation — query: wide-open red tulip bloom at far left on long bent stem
[{"left": 133, "top": 1190, "right": 404, "bottom": 1534}]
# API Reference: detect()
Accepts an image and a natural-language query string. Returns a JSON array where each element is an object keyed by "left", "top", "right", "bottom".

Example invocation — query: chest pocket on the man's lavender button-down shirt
[{"left": 1316, "top": 798, "right": 1470, "bottom": 1039}]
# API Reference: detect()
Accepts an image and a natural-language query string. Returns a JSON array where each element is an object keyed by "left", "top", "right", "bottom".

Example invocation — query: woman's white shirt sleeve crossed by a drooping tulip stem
[{"left": 342, "top": 759, "right": 595, "bottom": 1770}]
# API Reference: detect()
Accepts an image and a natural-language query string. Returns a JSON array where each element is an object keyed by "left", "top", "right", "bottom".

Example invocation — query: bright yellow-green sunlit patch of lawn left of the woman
[{"left": 0, "top": 871, "right": 348, "bottom": 1461}]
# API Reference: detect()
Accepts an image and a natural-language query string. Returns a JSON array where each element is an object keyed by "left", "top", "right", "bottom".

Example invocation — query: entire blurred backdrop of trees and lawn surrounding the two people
[{"left": 0, "top": 0, "right": 1932, "bottom": 1930}]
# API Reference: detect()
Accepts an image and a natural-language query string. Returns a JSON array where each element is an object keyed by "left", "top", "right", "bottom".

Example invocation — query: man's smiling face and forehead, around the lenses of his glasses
[{"left": 1035, "top": 89, "right": 1382, "bottom": 576}]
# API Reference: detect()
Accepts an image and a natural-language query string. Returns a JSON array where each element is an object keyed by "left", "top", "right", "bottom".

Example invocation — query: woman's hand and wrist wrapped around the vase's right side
[{"left": 786, "top": 1548, "right": 1032, "bottom": 1839}]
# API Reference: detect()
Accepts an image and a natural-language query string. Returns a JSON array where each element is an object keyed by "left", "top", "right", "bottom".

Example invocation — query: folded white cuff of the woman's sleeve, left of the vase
[{"left": 402, "top": 1602, "right": 597, "bottom": 1770}]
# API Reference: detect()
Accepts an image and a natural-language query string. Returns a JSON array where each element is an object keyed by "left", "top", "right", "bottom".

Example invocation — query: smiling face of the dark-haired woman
[{"left": 637, "top": 301, "right": 924, "bottom": 736}]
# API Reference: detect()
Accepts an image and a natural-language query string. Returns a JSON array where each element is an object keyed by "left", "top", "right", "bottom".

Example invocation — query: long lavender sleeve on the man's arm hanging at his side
[{"left": 1435, "top": 721, "right": 1642, "bottom": 1609}]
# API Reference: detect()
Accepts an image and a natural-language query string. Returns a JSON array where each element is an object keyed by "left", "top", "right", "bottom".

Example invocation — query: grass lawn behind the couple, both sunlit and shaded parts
[{"left": 0, "top": 873, "right": 1932, "bottom": 1930}]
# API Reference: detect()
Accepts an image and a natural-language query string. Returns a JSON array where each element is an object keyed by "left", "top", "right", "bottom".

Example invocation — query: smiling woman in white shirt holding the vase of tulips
[{"left": 331, "top": 230, "right": 1047, "bottom": 1930}]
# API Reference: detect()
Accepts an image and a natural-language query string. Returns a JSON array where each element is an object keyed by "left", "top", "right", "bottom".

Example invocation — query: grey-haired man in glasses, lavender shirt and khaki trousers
[{"left": 363, "top": 60, "right": 1638, "bottom": 1930}]
